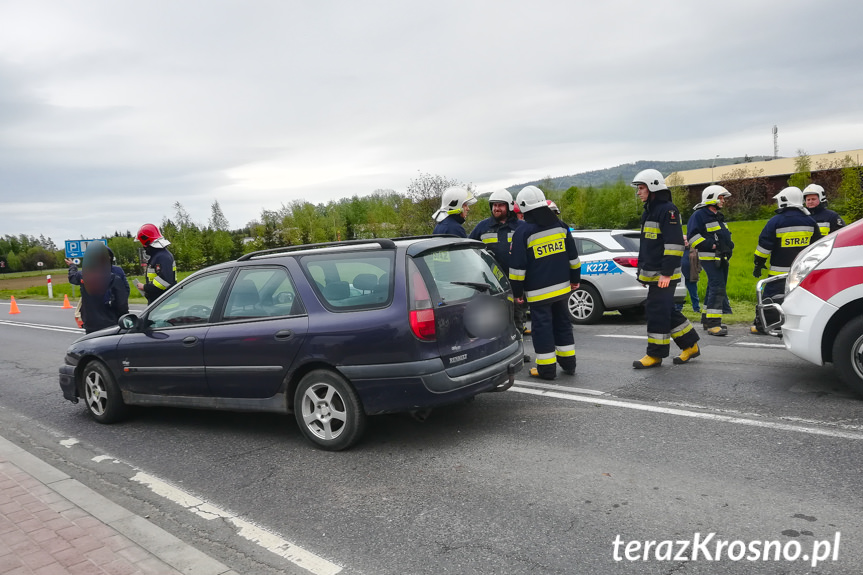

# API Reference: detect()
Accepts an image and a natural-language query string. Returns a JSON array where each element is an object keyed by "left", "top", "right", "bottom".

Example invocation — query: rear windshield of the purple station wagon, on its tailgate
[{"left": 414, "top": 248, "right": 509, "bottom": 304}]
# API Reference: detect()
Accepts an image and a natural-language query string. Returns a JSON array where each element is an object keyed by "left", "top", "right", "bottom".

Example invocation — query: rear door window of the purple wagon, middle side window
[{"left": 224, "top": 267, "right": 304, "bottom": 321}]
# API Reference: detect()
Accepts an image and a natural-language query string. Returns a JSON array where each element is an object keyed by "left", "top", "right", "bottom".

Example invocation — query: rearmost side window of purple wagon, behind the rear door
[{"left": 300, "top": 251, "right": 395, "bottom": 311}]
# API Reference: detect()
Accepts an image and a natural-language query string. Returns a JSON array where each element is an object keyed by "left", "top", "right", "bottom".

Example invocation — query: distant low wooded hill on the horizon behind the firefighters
[{"left": 507, "top": 156, "right": 773, "bottom": 193}]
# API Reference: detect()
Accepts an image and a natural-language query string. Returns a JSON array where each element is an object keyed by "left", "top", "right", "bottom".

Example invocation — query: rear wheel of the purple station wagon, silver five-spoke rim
[{"left": 294, "top": 369, "right": 366, "bottom": 451}]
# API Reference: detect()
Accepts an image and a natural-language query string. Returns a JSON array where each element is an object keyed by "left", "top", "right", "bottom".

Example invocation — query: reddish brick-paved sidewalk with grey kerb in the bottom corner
[{"left": 0, "top": 437, "right": 237, "bottom": 575}]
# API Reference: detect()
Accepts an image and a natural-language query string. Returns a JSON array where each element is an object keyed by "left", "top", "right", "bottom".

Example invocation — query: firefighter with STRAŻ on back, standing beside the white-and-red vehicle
[{"left": 749, "top": 186, "right": 821, "bottom": 334}]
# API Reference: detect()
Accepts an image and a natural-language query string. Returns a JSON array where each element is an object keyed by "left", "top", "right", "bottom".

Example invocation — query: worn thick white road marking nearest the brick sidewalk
[{"left": 132, "top": 472, "right": 342, "bottom": 575}]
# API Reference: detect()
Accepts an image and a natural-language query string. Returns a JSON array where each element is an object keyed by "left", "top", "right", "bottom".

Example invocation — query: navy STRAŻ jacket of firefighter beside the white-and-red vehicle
[{"left": 755, "top": 207, "right": 821, "bottom": 276}]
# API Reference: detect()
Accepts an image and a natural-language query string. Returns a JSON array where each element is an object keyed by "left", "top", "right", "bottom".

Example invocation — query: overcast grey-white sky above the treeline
[{"left": 0, "top": 0, "right": 863, "bottom": 247}]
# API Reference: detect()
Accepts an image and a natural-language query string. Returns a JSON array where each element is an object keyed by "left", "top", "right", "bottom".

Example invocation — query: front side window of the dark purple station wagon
[{"left": 147, "top": 270, "right": 230, "bottom": 328}]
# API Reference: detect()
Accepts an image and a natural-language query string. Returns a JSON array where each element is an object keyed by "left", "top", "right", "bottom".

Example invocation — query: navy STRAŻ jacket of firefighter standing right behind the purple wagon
[{"left": 509, "top": 218, "right": 581, "bottom": 304}]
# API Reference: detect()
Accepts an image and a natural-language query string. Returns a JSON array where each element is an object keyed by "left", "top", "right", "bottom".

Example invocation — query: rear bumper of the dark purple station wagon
[{"left": 338, "top": 339, "right": 524, "bottom": 415}]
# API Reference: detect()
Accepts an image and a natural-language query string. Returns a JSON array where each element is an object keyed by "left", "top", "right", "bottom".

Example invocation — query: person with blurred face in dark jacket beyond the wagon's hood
[{"left": 69, "top": 242, "right": 129, "bottom": 333}]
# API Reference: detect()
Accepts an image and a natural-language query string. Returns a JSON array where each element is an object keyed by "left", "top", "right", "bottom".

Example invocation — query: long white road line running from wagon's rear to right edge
[{"left": 510, "top": 385, "right": 863, "bottom": 439}]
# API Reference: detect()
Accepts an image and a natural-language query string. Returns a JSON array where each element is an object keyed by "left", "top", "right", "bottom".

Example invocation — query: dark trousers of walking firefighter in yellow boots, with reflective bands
[{"left": 644, "top": 280, "right": 699, "bottom": 357}]
